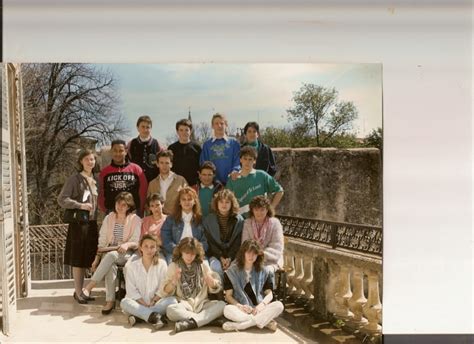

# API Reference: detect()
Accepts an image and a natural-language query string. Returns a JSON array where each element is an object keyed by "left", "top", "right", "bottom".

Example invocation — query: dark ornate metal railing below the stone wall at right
[{"left": 277, "top": 215, "right": 383, "bottom": 256}]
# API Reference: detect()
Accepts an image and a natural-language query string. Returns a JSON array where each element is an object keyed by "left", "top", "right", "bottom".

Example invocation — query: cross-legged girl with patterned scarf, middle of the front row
[{"left": 161, "top": 237, "right": 225, "bottom": 333}]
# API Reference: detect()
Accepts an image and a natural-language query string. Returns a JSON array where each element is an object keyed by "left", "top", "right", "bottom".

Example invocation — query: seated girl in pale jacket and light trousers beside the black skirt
[{"left": 83, "top": 192, "right": 141, "bottom": 315}]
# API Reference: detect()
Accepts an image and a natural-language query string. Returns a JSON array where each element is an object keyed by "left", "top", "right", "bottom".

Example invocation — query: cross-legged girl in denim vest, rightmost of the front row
[{"left": 222, "top": 239, "right": 283, "bottom": 331}]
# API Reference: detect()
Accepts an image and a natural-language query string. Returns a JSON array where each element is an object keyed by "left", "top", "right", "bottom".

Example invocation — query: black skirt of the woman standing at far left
[{"left": 64, "top": 221, "right": 99, "bottom": 268}]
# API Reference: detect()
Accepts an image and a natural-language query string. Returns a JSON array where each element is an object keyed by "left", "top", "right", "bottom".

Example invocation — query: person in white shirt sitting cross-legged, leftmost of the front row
[{"left": 120, "top": 234, "right": 177, "bottom": 329}]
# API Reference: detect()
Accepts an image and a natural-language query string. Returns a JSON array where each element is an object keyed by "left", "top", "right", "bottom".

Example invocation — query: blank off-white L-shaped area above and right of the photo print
[{"left": 3, "top": 0, "right": 474, "bottom": 334}]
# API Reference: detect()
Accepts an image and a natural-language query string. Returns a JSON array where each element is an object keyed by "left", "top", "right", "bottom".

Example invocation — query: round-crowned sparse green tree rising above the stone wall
[{"left": 287, "top": 84, "right": 358, "bottom": 147}]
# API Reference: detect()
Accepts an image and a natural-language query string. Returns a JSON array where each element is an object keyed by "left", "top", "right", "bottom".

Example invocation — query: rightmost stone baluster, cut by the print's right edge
[{"left": 361, "top": 272, "right": 382, "bottom": 334}]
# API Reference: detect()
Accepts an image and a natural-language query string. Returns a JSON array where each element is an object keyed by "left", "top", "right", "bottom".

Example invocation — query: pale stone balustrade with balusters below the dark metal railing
[{"left": 284, "top": 237, "right": 382, "bottom": 336}]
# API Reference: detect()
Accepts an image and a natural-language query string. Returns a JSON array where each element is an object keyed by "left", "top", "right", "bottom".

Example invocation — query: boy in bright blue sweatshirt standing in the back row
[{"left": 199, "top": 113, "right": 240, "bottom": 185}]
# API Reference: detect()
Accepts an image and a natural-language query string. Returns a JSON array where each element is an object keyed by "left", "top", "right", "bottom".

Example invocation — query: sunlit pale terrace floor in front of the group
[{"left": 0, "top": 280, "right": 312, "bottom": 343}]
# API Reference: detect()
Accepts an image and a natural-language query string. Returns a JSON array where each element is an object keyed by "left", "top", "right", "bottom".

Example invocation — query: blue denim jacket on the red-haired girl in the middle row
[{"left": 161, "top": 216, "right": 208, "bottom": 264}]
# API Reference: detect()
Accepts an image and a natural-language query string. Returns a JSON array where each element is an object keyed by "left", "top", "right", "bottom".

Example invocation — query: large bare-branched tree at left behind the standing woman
[{"left": 22, "top": 63, "right": 125, "bottom": 224}]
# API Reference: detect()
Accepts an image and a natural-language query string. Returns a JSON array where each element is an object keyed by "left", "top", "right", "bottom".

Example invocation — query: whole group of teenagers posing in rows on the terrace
[{"left": 58, "top": 113, "right": 284, "bottom": 332}]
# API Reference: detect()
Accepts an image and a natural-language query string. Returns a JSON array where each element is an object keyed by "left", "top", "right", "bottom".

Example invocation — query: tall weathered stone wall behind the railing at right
[{"left": 273, "top": 148, "right": 382, "bottom": 226}]
